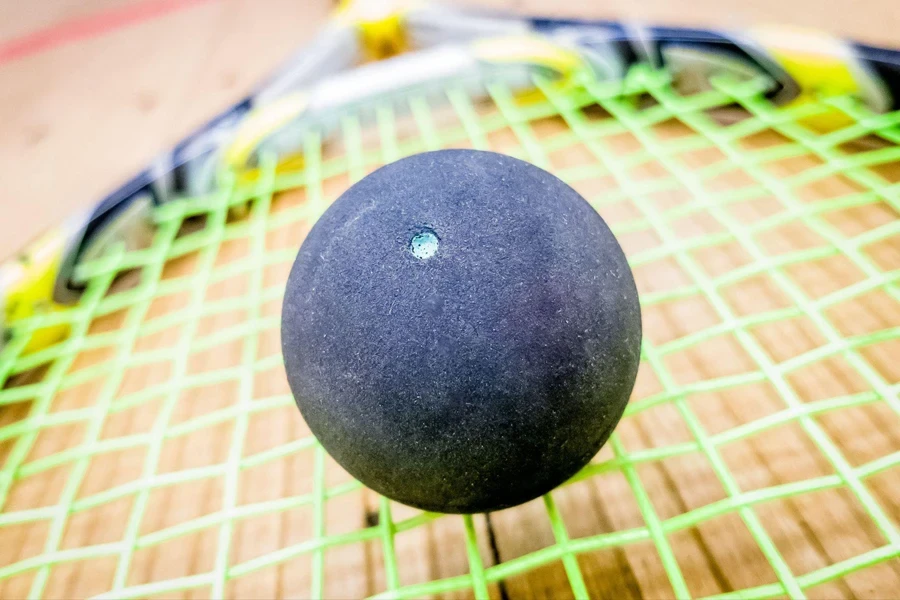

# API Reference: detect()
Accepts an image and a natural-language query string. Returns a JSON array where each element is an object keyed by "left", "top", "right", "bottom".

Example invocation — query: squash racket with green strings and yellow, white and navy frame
[{"left": 0, "top": 4, "right": 900, "bottom": 598}]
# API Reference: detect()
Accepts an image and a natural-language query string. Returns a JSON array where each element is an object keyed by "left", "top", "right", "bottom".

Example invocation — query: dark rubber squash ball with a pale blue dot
[{"left": 281, "top": 150, "right": 641, "bottom": 513}]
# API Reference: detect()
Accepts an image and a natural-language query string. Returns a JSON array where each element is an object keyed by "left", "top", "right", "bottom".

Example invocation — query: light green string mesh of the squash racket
[{"left": 0, "top": 67, "right": 900, "bottom": 598}]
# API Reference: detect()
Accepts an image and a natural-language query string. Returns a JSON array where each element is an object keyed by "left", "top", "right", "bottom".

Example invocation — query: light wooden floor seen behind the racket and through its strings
[{"left": 0, "top": 0, "right": 900, "bottom": 599}]
